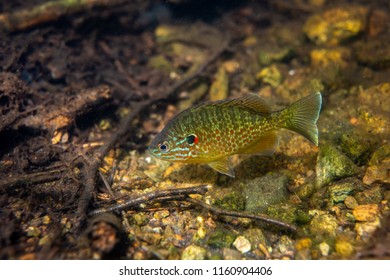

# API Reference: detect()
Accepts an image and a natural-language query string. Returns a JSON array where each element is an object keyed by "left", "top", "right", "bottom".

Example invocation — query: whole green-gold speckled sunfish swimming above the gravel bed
[{"left": 149, "top": 92, "right": 322, "bottom": 177}]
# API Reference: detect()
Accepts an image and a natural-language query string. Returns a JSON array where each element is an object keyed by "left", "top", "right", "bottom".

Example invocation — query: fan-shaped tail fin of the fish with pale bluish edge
[{"left": 283, "top": 92, "right": 322, "bottom": 145}]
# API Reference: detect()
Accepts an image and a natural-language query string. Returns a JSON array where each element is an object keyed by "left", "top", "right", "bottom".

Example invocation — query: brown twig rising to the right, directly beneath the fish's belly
[{"left": 89, "top": 185, "right": 209, "bottom": 215}]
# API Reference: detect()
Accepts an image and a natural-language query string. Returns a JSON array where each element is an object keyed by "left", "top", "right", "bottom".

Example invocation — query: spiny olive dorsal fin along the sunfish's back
[{"left": 191, "top": 93, "right": 271, "bottom": 116}]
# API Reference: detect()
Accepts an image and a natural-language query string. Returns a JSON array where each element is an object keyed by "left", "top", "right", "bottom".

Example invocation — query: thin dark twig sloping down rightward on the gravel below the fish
[{"left": 185, "top": 197, "right": 297, "bottom": 233}]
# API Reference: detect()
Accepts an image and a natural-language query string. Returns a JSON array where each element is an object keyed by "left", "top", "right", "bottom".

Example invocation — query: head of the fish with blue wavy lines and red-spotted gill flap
[{"left": 149, "top": 127, "right": 199, "bottom": 162}]
